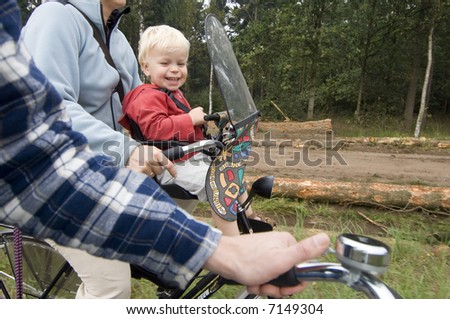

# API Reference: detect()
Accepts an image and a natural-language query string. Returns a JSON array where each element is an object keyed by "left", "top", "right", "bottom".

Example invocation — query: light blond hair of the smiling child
[{"left": 138, "top": 25, "right": 190, "bottom": 65}]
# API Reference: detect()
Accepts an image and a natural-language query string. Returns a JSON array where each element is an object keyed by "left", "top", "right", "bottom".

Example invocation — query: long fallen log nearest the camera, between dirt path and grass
[{"left": 246, "top": 176, "right": 450, "bottom": 211}]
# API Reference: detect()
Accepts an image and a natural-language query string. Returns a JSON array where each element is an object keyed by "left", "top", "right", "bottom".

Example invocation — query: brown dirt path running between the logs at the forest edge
[{"left": 250, "top": 123, "right": 450, "bottom": 187}]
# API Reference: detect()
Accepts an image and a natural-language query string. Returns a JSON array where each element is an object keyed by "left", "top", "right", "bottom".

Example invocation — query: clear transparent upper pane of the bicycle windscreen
[{"left": 205, "top": 15, "right": 258, "bottom": 124}]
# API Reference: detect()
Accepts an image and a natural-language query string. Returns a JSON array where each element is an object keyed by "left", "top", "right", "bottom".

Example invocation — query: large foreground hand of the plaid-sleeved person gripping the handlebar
[{"left": 204, "top": 232, "right": 330, "bottom": 298}]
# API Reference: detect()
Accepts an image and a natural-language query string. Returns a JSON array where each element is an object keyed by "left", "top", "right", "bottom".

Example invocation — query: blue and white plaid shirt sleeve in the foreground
[{"left": 0, "top": 0, "right": 221, "bottom": 286}]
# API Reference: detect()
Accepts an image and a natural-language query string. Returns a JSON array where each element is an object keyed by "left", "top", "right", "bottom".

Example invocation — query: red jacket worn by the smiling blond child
[{"left": 119, "top": 84, "right": 204, "bottom": 142}]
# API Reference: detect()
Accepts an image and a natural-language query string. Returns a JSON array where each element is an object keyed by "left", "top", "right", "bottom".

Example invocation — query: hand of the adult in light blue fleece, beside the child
[{"left": 126, "top": 145, "right": 177, "bottom": 177}]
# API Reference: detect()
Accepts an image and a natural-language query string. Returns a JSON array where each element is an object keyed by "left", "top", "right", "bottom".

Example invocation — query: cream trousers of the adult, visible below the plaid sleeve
[{"left": 47, "top": 240, "right": 131, "bottom": 299}]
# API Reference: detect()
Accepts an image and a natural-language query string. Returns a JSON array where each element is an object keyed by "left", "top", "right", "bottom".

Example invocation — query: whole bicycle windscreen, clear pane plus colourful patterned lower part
[{"left": 205, "top": 15, "right": 259, "bottom": 221}]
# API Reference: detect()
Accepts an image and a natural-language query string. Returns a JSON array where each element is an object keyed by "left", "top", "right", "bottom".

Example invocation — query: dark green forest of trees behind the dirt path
[{"left": 19, "top": 0, "right": 450, "bottom": 137}]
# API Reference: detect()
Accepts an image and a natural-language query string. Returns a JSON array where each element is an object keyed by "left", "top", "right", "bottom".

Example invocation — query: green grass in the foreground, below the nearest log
[{"left": 0, "top": 202, "right": 450, "bottom": 299}]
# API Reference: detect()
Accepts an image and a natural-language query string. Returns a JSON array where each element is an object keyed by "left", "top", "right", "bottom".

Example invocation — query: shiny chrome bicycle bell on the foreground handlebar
[{"left": 336, "top": 234, "right": 390, "bottom": 276}]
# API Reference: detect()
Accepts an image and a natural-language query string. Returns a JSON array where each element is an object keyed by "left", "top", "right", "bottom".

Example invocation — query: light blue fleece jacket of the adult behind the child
[{"left": 22, "top": 0, "right": 141, "bottom": 166}]
